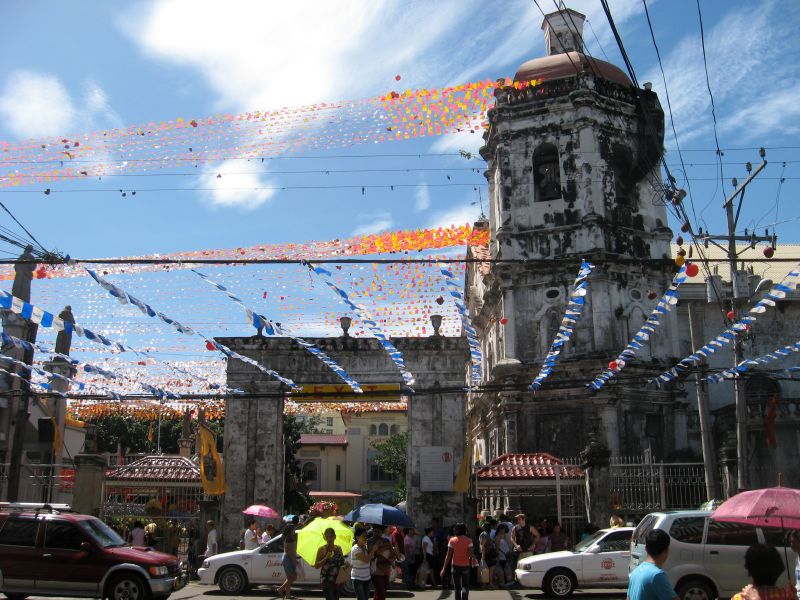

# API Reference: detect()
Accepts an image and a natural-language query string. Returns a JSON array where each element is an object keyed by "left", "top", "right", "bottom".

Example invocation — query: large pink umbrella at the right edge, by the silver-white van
[{"left": 711, "top": 486, "right": 800, "bottom": 529}]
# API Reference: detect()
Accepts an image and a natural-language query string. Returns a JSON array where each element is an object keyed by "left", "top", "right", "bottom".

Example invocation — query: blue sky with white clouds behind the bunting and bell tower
[{"left": 0, "top": 0, "right": 800, "bottom": 394}]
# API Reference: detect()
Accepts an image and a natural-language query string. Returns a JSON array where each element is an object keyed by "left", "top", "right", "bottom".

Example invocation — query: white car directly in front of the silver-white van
[{"left": 516, "top": 527, "right": 633, "bottom": 598}]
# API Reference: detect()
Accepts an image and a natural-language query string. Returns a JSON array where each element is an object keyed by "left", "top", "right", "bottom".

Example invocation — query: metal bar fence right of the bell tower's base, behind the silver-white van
[{"left": 610, "top": 456, "right": 706, "bottom": 513}]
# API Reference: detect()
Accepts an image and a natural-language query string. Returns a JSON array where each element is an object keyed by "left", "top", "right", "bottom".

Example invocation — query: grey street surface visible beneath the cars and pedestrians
[{"left": 0, "top": 583, "right": 625, "bottom": 600}]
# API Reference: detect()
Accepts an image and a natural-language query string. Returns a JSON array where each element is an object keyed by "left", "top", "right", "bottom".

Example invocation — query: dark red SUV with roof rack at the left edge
[{"left": 0, "top": 503, "right": 184, "bottom": 600}]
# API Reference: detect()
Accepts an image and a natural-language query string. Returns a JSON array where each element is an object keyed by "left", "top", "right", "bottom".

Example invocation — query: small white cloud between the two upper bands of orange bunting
[{"left": 198, "top": 160, "right": 277, "bottom": 210}]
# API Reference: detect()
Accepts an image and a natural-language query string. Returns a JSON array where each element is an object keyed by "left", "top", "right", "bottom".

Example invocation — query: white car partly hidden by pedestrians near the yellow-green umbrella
[{"left": 197, "top": 535, "right": 353, "bottom": 596}]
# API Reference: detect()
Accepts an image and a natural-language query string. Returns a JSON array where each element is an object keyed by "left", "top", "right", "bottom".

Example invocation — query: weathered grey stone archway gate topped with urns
[{"left": 217, "top": 336, "right": 469, "bottom": 547}]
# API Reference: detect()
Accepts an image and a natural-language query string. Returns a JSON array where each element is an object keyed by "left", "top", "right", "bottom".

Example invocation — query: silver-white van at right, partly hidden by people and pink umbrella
[{"left": 630, "top": 510, "right": 797, "bottom": 600}]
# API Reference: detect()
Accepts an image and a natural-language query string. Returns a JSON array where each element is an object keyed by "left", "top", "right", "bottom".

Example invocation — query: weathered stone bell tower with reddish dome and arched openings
[{"left": 466, "top": 9, "right": 680, "bottom": 462}]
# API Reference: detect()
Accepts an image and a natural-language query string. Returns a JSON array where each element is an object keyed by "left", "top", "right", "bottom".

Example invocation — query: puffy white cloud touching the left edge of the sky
[{"left": 0, "top": 71, "right": 76, "bottom": 138}]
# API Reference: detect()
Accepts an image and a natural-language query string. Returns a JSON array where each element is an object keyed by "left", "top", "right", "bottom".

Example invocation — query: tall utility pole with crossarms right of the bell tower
[{"left": 698, "top": 148, "right": 776, "bottom": 491}]
